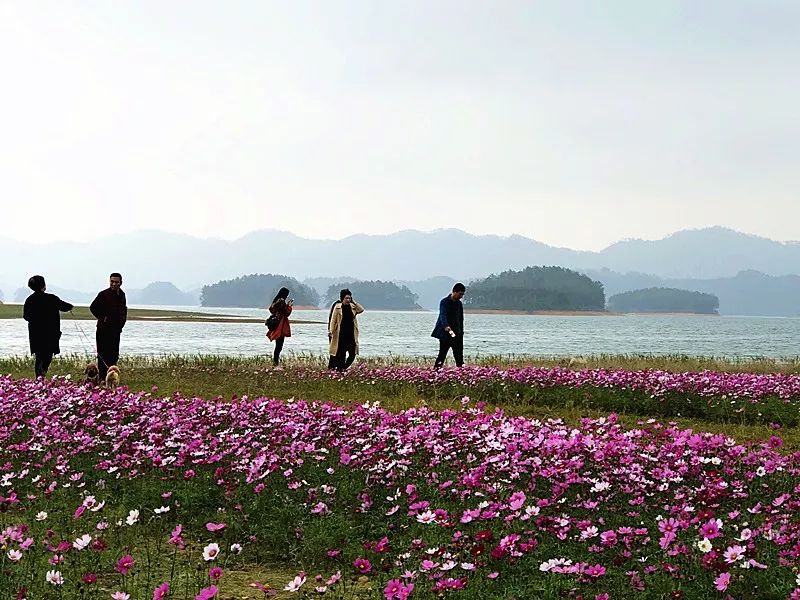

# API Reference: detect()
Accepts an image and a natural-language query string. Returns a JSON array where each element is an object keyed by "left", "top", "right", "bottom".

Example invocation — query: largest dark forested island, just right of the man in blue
[{"left": 463, "top": 267, "right": 605, "bottom": 312}]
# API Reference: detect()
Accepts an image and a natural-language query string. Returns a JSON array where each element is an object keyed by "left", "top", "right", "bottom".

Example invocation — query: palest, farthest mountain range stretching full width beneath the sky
[{"left": 0, "top": 227, "right": 800, "bottom": 292}]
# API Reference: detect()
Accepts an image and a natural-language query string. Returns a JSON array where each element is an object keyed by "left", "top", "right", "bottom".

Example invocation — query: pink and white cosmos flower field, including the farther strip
[{"left": 0, "top": 367, "right": 800, "bottom": 600}]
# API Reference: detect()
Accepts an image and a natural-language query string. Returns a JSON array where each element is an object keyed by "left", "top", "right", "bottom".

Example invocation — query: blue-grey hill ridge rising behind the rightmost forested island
[{"left": 584, "top": 269, "right": 800, "bottom": 317}]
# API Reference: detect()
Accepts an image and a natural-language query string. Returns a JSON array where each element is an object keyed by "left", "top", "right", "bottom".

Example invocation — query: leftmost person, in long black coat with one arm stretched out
[{"left": 22, "top": 275, "right": 72, "bottom": 377}]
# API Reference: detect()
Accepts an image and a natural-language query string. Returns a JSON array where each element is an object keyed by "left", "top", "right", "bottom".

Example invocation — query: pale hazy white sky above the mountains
[{"left": 0, "top": 0, "right": 800, "bottom": 248}]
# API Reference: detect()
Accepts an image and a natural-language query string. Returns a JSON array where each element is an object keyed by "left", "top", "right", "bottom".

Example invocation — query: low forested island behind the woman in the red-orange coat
[{"left": 200, "top": 273, "right": 319, "bottom": 308}]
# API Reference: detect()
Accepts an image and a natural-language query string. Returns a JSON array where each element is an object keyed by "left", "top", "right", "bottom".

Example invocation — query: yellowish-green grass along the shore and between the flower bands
[{"left": 6, "top": 355, "right": 800, "bottom": 450}]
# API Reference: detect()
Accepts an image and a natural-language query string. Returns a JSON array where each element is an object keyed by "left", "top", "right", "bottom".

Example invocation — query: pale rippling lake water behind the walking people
[{"left": 0, "top": 307, "right": 800, "bottom": 358}]
